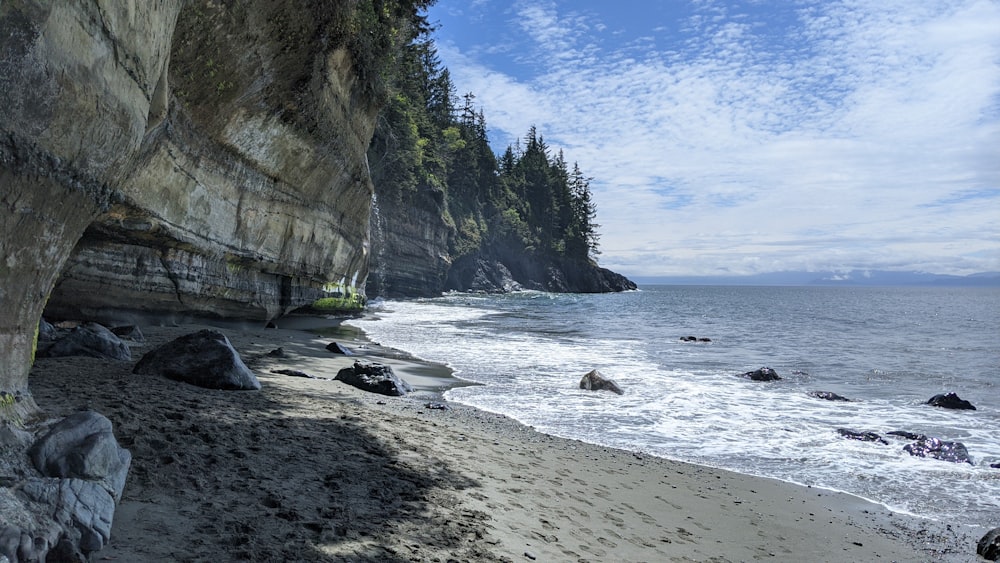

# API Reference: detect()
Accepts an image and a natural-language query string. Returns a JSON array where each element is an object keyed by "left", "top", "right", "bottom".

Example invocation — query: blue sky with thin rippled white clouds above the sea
[{"left": 428, "top": 0, "right": 1000, "bottom": 276}]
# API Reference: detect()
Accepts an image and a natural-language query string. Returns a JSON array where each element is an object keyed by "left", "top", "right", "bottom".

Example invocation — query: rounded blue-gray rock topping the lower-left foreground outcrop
[{"left": 28, "top": 411, "right": 132, "bottom": 500}]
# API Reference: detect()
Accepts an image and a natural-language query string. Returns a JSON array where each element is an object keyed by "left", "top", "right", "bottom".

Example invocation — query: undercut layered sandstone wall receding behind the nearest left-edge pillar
[{"left": 47, "top": 1, "right": 376, "bottom": 319}]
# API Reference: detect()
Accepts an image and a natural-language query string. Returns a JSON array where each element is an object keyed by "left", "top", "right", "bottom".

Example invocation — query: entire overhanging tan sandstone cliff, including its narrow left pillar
[{"left": 0, "top": 0, "right": 377, "bottom": 419}]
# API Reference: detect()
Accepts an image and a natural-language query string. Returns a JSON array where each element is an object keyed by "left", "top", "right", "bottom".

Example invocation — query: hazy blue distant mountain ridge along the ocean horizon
[{"left": 632, "top": 270, "right": 1000, "bottom": 287}]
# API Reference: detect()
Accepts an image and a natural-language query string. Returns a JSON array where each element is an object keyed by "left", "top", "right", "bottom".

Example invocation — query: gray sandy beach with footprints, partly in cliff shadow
[{"left": 30, "top": 324, "right": 978, "bottom": 562}]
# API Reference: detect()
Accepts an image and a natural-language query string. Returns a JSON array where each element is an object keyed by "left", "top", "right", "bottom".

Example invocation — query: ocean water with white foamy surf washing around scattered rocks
[{"left": 348, "top": 286, "right": 1000, "bottom": 527}]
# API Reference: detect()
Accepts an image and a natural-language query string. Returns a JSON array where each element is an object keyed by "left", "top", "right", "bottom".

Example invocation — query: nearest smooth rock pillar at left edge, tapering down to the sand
[{"left": 0, "top": 0, "right": 181, "bottom": 418}]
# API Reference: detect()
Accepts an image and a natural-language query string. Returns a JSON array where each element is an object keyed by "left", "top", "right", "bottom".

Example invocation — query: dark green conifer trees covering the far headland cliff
[{"left": 368, "top": 4, "right": 598, "bottom": 263}]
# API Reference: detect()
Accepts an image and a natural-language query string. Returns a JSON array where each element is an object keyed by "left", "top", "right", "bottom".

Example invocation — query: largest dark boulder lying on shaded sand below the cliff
[{"left": 132, "top": 329, "right": 260, "bottom": 390}]
